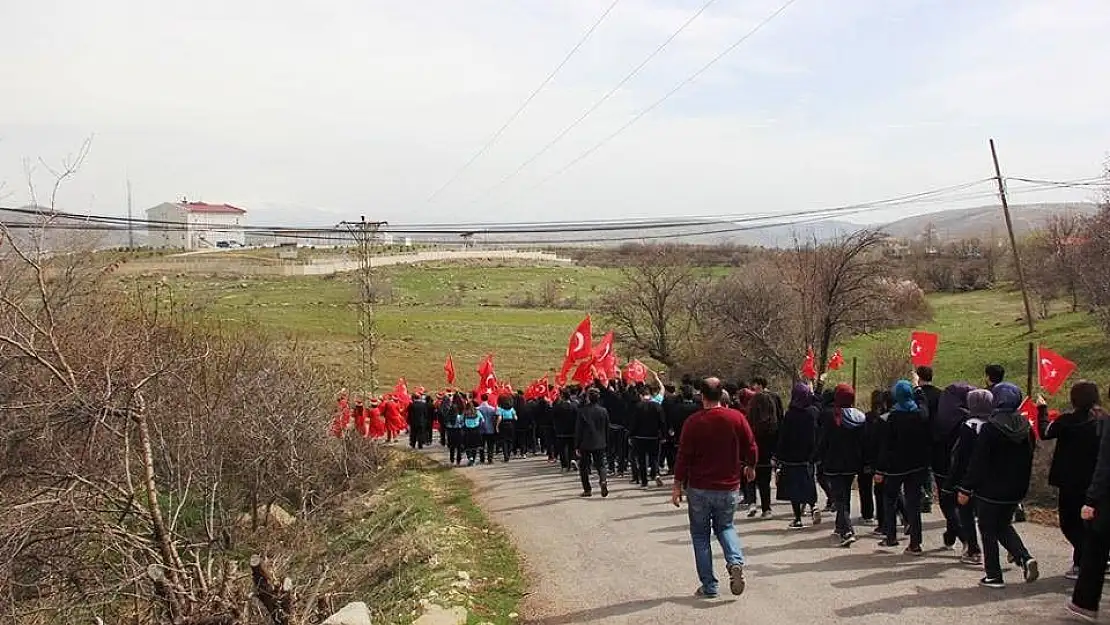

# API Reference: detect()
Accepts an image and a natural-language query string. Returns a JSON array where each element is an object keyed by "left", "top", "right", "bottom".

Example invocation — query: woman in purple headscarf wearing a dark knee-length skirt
[{"left": 775, "top": 384, "right": 821, "bottom": 530}]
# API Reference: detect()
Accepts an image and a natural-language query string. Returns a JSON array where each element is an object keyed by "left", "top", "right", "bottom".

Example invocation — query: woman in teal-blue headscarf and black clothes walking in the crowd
[{"left": 875, "top": 380, "right": 931, "bottom": 555}]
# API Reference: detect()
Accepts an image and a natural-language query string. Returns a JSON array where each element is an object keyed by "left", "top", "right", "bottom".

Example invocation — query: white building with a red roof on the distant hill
[{"left": 147, "top": 200, "right": 246, "bottom": 250}]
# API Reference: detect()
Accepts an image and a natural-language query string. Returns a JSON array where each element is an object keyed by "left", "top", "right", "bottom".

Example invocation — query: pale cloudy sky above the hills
[{"left": 0, "top": 0, "right": 1110, "bottom": 225}]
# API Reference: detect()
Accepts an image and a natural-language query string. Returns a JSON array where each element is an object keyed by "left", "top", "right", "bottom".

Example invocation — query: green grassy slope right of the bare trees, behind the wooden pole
[{"left": 830, "top": 291, "right": 1110, "bottom": 395}]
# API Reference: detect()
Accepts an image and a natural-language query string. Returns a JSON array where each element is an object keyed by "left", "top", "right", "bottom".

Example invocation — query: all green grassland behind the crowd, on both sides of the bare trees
[{"left": 136, "top": 264, "right": 1110, "bottom": 404}]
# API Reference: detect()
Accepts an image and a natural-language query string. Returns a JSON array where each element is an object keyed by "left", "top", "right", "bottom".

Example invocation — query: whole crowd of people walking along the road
[{"left": 333, "top": 365, "right": 1110, "bottom": 621}]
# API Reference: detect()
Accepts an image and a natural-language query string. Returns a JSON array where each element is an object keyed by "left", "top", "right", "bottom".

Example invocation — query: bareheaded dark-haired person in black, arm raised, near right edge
[{"left": 1037, "top": 380, "right": 1102, "bottom": 579}]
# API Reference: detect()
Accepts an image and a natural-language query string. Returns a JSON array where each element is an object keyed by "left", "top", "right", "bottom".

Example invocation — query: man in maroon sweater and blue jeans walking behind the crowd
[{"left": 670, "top": 377, "right": 758, "bottom": 598}]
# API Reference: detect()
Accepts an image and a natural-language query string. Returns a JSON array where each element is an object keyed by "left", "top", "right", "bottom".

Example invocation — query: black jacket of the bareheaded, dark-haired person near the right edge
[{"left": 1037, "top": 406, "right": 1100, "bottom": 493}]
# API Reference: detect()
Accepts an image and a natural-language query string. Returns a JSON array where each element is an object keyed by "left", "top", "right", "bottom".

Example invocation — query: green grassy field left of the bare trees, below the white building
[{"left": 140, "top": 264, "right": 617, "bottom": 387}]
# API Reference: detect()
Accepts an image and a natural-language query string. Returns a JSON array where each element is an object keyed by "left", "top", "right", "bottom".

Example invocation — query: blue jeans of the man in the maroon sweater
[{"left": 686, "top": 488, "right": 744, "bottom": 595}]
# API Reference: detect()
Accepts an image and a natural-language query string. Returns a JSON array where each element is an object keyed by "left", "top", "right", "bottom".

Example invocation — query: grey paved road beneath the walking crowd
[{"left": 448, "top": 458, "right": 1092, "bottom": 625}]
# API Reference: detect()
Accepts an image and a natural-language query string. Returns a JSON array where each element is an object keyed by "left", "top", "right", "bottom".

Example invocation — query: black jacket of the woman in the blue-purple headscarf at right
[{"left": 958, "top": 420, "right": 1035, "bottom": 504}]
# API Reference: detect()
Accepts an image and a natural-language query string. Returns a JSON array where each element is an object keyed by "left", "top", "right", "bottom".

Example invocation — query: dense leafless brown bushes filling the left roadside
[{"left": 0, "top": 222, "right": 375, "bottom": 625}]
